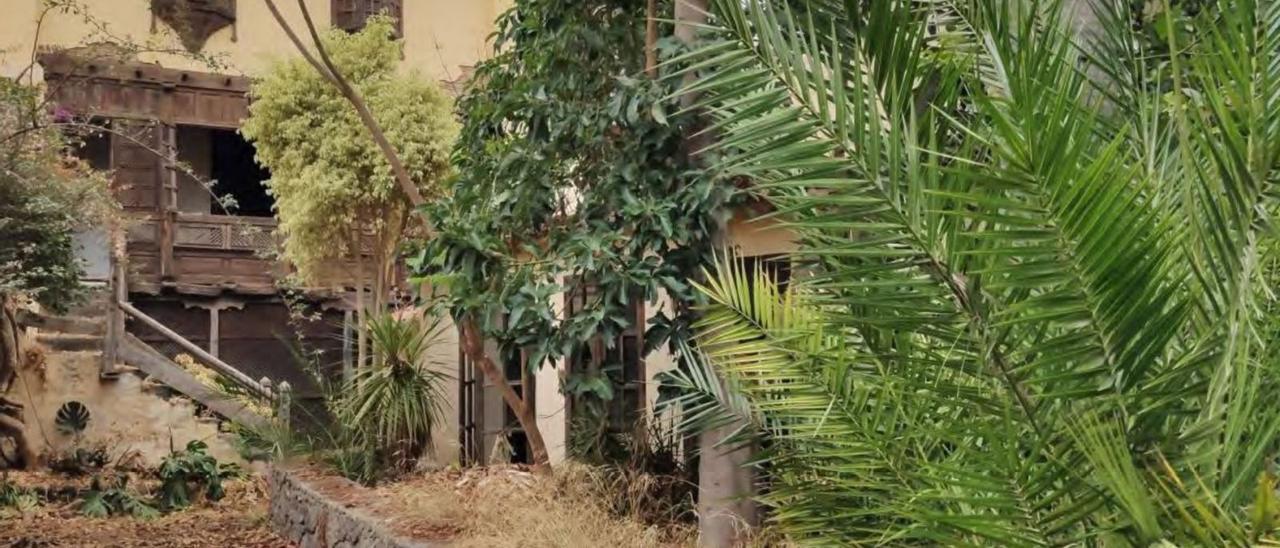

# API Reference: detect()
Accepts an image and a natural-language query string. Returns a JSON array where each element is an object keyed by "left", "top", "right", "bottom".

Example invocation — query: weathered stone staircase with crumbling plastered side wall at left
[{"left": 18, "top": 292, "right": 269, "bottom": 463}]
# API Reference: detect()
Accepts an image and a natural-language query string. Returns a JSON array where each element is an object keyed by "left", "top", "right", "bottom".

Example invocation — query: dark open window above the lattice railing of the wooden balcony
[{"left": 177, "top": 125, "right": 274, "bottom": 216}]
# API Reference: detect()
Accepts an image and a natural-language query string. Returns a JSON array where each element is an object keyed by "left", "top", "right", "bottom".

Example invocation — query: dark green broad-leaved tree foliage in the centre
[{"left": 413, "top": 0, "right": 730, "bottom": 448}]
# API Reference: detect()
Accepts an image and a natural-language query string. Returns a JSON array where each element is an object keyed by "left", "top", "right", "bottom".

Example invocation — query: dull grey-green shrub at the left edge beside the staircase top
[{"left": 0, "top": 79, "right": 114, "bottom": 310}]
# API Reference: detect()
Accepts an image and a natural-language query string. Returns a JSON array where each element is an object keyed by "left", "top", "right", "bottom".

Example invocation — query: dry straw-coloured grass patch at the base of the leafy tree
[{"left": 350, "top": 463, "right": 698, "bottom": 548}]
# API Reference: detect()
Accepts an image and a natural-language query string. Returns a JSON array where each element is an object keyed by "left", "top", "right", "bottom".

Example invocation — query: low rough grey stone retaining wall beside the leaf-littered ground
[{"left": 269, "top": 466, "right": 442, "bottom": 548}]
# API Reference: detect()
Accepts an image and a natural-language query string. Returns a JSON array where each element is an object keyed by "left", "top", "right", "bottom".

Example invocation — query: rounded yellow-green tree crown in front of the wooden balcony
[{"left": 241, "top": 18, "right": 457, "bottom": 283}]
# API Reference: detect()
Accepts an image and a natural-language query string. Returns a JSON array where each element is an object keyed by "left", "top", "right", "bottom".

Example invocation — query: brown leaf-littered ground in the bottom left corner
[{"left": 0, "top": 471, "right": 293, "bottom": 548}]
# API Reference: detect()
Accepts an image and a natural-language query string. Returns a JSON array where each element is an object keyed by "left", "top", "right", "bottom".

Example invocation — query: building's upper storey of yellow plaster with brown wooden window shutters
[{"left": 0, "top": 0, "right": 512, "bottom": 82}]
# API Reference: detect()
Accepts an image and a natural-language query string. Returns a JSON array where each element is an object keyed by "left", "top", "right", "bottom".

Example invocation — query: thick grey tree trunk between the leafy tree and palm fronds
[{"left": 676, "top": 0, "right": 758, "bottom": 547}]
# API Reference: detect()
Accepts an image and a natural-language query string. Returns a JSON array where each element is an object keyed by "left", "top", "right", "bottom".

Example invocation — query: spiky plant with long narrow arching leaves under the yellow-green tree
[{"left": 334, "top": 314, "right": 447, "bottom": 481}]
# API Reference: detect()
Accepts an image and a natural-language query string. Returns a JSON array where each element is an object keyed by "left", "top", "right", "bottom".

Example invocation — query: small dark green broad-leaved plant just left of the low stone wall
[{"left": 156, "top": 439, "right": 241, "bottom": 511}]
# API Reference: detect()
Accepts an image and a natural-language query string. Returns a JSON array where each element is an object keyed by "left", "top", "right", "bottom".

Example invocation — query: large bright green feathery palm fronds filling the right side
[{"left": 675, "top": 0, "right": 1280, "bottom": 545}]
